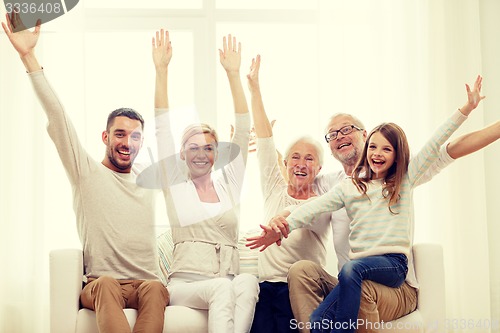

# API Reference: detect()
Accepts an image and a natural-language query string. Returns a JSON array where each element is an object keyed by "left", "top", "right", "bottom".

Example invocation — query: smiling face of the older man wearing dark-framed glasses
[{"left": 327, "top": 115, "right": 366, "bottom": 169}]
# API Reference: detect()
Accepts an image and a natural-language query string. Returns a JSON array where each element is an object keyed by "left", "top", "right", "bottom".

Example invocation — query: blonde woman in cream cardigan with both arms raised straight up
[{"left": 153, "top": 30, "right": 258, "bottom": 333}]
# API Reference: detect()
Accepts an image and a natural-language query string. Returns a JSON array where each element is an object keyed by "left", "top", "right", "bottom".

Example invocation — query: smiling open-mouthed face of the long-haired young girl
[{"left": 366, "top": 132, "right": 396, "bottom": 179}]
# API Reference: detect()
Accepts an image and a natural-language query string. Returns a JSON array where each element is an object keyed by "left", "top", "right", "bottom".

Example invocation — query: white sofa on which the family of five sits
[{"left": 50, "top": 239, "right": 445, "bottom": 333}]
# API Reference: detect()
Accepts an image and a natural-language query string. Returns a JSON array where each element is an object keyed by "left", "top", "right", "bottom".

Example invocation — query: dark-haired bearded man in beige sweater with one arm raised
[{"left": 2, "top": 12, "right": 169, "bottom": 333}]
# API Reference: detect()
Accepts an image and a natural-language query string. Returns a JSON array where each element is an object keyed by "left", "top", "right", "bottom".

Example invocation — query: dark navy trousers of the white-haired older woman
[{"left": 250, "top": 281, "right": 298, "bottom": 333}]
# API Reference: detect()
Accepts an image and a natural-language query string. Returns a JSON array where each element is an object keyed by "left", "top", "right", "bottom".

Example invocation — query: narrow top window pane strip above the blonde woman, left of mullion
[{"left": 85, "top": 0, "right": 203, "bottom": 9}]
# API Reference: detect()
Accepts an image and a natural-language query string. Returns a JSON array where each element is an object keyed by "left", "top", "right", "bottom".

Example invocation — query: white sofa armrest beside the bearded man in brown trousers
[{"left": 49, "top": 249, "right": 83, "bottom": 333}]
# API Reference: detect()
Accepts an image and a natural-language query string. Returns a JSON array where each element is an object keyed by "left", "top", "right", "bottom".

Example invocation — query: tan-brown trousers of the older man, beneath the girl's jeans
[{"left": 288, "top": 260, "right": 417, "bottom": 333}]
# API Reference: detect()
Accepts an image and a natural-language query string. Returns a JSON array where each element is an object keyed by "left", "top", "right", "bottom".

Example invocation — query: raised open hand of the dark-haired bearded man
[{"left": 2, "top": 11, "right": 42, "bottom": 58}]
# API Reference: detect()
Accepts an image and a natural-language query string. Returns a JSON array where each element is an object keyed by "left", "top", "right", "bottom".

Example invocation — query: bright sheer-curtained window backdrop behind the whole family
[{"left": 0, "top": 0, "right": 500, "bottom": 333}]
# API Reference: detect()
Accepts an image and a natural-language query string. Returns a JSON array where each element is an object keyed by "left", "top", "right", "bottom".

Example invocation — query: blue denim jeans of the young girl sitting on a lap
[{"left": 311, "top": 253, "right": 408, "bottom": 333}]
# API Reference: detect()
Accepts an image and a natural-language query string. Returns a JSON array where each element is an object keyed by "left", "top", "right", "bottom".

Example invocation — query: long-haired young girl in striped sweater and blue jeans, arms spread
[{"left": 248, "top": 76, "right": 484, "bottom": 332}]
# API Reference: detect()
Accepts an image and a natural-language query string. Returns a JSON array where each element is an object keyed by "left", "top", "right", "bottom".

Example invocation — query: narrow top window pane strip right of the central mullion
[{"left": 216, "top": 0, "right": 318, "bottom": 9}]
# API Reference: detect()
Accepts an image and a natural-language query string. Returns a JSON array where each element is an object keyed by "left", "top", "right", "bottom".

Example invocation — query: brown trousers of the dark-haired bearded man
[{"left": 80, "top": 276, "right": 169, "bottom": 333}]
